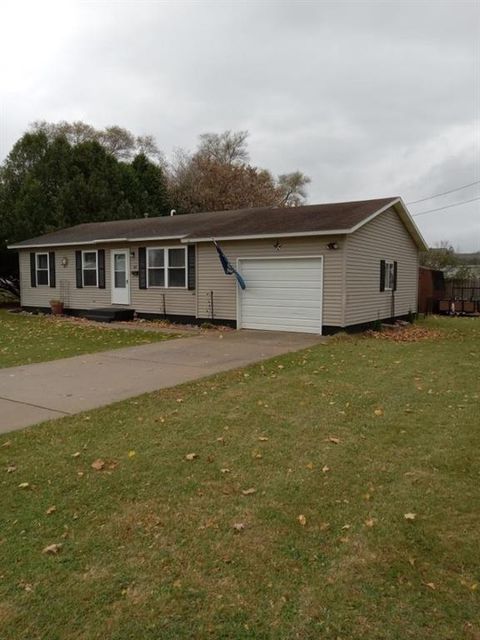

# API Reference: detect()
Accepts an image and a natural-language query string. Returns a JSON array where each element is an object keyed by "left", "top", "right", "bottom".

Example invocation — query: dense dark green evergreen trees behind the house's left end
[{"left": 0, "top": 129, "right": 170, "bottom": 275}]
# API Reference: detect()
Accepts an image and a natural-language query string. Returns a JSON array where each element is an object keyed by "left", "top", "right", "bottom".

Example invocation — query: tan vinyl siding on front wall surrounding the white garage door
[{"left": 197, "top": 236, "right": 343, "bottom": 326}]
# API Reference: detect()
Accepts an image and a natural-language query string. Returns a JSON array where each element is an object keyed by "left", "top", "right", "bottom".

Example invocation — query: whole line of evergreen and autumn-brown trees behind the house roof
[{"left": 0, "top": 121, "right": 310, "bottom": 275}]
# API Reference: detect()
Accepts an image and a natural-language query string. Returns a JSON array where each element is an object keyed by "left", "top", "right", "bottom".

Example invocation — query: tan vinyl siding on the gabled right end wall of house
[{"left": 345, "top": 209, "right": 418, "bottom": 326}]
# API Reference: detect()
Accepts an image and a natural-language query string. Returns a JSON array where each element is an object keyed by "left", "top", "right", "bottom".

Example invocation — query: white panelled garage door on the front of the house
[{"left": 238, "top": 258, "right": 323, "bottom": 333}]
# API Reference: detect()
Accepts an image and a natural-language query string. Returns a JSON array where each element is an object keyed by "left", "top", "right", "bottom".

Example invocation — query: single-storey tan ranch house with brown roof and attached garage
[{"left": 9, "top": 198, "right": 426, "bottom": 333}]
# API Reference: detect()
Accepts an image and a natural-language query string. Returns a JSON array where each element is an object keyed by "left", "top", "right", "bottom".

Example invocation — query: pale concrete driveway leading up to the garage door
[{"left": 0, "top": 330, "right": 322, "bottom": 433}]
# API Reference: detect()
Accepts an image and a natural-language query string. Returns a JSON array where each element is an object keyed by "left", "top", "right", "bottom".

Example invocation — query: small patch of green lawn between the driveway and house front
[{"left": 0, "top": 309, "right": 177, "bottom": 368}]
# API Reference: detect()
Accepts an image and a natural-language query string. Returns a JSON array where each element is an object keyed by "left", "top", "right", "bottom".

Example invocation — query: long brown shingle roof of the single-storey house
[{"left": 12, "top": 198, "right": 397, "bottom": 248}]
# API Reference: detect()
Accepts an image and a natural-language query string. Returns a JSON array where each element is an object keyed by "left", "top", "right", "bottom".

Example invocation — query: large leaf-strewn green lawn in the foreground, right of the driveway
[{"left": 0, "top": 319, "right": 480, "bottom": 640}]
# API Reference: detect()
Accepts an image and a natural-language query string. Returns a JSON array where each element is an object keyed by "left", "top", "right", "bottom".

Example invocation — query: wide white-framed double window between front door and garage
[{"left": 147, "top": 247, "right": 187, "bottom": 289}]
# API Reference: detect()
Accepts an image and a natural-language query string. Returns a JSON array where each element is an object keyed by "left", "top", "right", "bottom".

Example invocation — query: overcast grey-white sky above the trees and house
[{"left": 0, "top": 0, "right": 480, "bottom": 250}]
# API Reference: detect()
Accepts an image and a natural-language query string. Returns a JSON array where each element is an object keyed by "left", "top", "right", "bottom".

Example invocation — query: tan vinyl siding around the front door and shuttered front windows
[{"left": 20, "top": 241, "right": 196, "bottom": 316}]
